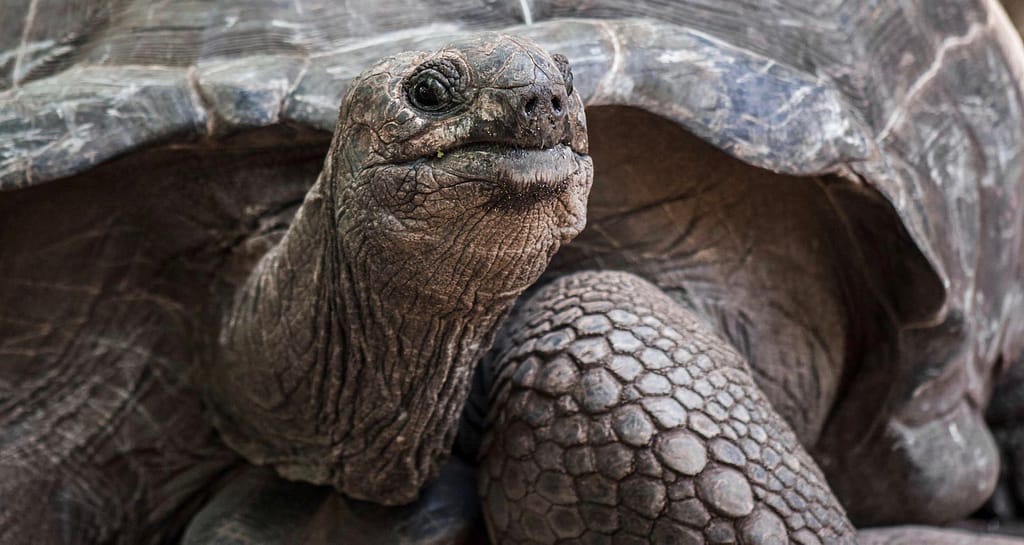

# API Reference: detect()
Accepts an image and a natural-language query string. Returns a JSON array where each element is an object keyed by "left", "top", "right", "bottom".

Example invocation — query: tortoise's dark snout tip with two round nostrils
[{"left": 516, "top": 78, "right": 570, "bottom": 148}]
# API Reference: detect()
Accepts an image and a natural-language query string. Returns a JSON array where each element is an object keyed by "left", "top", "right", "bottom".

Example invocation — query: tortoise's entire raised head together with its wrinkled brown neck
[{"left": 204, "top": 35, "right": 593, "bottom": 504}]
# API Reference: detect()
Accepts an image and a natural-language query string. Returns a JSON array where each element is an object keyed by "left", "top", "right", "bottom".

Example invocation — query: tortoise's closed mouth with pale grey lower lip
[{"left": 428, "top": 142, "right": 586, "bottom": 198}]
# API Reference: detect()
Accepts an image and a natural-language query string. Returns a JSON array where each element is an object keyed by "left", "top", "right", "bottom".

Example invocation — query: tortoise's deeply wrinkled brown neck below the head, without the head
[{"left": 208, "top": 168, "right": 512, "bottom": 503}]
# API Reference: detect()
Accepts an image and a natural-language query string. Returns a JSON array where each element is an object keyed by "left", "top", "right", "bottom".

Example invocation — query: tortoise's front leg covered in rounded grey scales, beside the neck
[{"left": 480, "top": 273, "right": 854, "bottom": 545}]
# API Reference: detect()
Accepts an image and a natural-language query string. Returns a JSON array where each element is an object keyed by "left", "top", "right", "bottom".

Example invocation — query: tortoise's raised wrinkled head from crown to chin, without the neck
[{"left": 325, "top": 34, "right": 593, "bottom": 305}]
